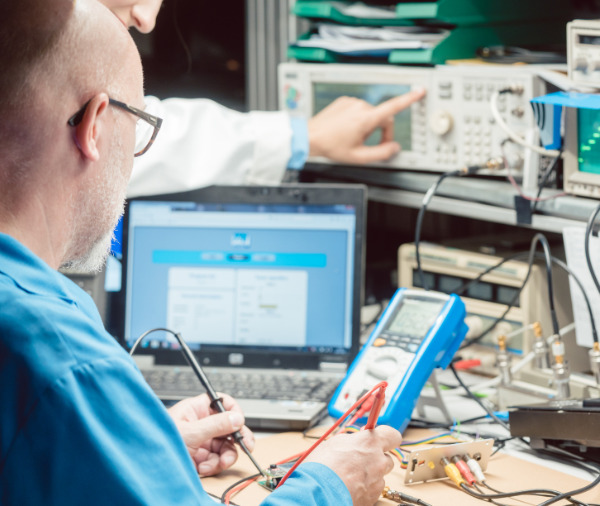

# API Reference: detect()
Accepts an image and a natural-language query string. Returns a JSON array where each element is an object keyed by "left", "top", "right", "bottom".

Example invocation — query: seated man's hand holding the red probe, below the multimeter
[{"left": 305, "top": 425, "right": 402, "bottom": 505}]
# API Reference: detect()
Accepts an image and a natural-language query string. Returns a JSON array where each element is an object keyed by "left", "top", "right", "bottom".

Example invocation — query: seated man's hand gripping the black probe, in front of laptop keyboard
[{"left": 169, "top": 394, "right": 254, "bottom": 476}]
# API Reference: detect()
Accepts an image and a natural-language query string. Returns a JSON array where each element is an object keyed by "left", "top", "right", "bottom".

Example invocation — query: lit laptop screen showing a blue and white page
[{"left": 125, "top": 201, "right": 356, "bottom": 353}]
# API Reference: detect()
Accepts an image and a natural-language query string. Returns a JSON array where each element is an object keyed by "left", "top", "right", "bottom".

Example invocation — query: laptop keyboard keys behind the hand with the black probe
[{"left": 142, "top": 368, "right": 340, "bottom": 402}]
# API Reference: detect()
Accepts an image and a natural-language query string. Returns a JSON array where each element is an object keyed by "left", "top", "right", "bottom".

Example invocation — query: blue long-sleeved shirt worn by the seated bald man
[{"left": 0, "top": 234, "right": 351, "bottom": 506}]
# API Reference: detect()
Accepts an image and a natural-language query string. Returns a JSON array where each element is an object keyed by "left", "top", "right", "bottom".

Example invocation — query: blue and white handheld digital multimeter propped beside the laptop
[{"left": 329, "top": 288, "right": 468, "bottom": 431}]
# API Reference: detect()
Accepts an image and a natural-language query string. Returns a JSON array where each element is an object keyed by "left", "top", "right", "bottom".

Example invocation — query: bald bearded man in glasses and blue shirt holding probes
[{"left": 0, "top": 0, "right": 401, "bottom": 506}]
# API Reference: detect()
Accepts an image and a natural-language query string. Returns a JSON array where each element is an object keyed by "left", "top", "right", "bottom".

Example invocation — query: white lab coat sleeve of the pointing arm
[{"left": 127, "top": 97, "right": 292, "bottom": 197}]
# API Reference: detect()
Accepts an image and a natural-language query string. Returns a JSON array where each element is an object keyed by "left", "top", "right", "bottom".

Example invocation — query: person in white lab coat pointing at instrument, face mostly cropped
[{"left": 100, "top": 0, "right": 425, "bottom": 197}]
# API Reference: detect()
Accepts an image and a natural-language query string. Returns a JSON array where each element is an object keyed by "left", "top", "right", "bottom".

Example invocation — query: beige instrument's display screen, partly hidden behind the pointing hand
[{"left": 313, "top": 83, "right": 411, "bottom": 151}]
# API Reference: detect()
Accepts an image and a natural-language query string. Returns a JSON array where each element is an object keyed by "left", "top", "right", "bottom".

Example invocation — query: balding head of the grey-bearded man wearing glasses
[{"left": 0, "top": 0, "right": 143, "bottom": 269}]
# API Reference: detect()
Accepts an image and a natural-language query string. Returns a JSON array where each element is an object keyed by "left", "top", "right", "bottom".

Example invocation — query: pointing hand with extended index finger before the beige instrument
[{"left": 308, "top": 89, "right": 425, "bottom": 164}]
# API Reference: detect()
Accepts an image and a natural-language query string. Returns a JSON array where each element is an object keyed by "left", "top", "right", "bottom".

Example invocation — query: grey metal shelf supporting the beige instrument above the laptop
[{"left": 302, "top": 165, "right": 598, "bottom": 233}]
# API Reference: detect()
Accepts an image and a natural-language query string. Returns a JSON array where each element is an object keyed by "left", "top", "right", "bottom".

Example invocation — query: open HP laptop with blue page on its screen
[{"left": 122, "top": 184, "right": 366, "bottom": 430}]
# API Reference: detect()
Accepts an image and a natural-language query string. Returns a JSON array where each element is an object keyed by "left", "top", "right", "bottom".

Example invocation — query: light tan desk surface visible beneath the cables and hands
[{"left": 202, "top": 429, "right": 600, "bottom": 506}]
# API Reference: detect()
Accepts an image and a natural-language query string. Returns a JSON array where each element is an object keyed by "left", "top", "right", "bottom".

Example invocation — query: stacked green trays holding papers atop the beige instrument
[{"left": 288, "top": 0, "right": 575, "bottom": 64}]
